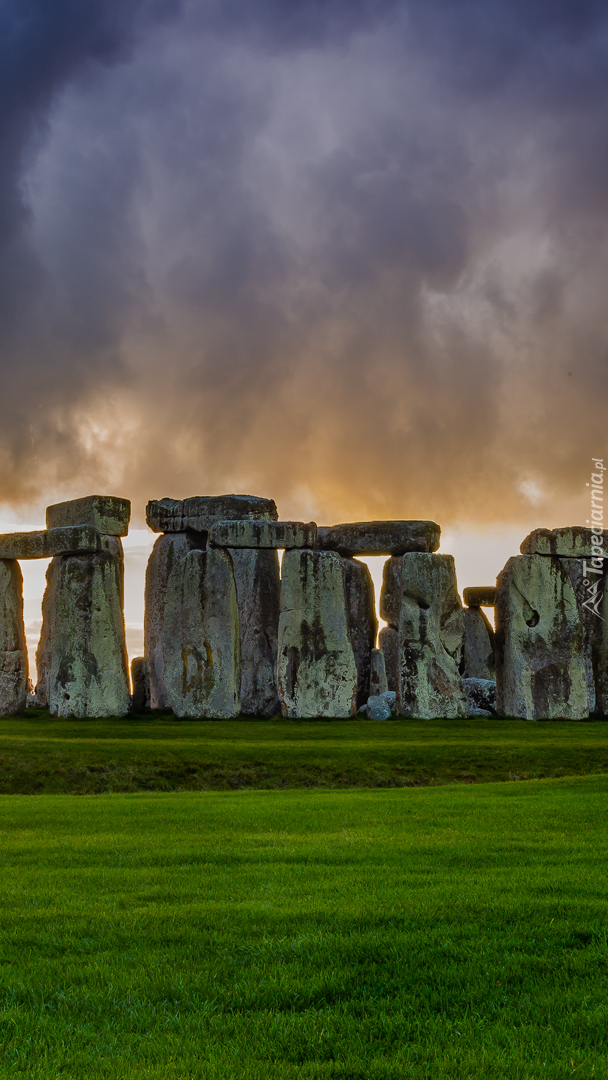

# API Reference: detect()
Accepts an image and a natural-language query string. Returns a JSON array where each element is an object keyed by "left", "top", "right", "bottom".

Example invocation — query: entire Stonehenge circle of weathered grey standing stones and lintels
[{"left": 0, "top": 486, "right": 608, "bottom": 719}]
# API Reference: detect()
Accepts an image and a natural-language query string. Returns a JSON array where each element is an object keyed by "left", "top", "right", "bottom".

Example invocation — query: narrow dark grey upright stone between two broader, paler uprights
[{"left": 230, "top": 548, "right": 281, "bottom": 716}]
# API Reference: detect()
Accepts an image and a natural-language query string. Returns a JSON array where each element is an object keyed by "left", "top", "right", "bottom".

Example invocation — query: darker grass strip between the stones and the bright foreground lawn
[{"left": 0, "top": 711, "right": 608, "bottom": 794}]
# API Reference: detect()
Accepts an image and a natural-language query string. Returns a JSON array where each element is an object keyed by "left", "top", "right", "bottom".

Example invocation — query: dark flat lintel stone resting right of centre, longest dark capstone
[{"left": 317, "top": 521, "right": 441, "bottom": 556}]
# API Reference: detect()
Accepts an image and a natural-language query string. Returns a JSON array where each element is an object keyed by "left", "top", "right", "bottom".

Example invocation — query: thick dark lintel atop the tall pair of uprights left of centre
[{"left": 146, "top": 495, "right": 279, "bottom": 532}]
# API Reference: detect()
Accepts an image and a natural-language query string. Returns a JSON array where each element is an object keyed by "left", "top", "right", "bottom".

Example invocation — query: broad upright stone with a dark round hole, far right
[{"left": 496, "top": 555, "right": 590, "bottom": 720}]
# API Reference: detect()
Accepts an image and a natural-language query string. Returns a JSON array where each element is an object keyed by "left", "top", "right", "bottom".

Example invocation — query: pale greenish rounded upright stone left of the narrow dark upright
[{"left": 161, "top": 549, "right": 241, "bottom": 719}]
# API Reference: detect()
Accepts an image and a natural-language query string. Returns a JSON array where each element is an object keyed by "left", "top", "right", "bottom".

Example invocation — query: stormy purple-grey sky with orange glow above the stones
[{"left": 0, "top": 0, "right": 608, "bottom": 665}]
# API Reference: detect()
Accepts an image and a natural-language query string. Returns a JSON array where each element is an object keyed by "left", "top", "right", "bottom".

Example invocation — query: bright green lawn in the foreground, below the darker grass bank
[{"left": 0, "top": 777, "right": 608, "bottom": 1080}]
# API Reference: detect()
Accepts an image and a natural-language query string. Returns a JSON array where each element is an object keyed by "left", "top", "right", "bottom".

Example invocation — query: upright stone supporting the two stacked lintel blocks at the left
[{"left": 37, "top": 536, "right": 130, "bottom": 717}]
